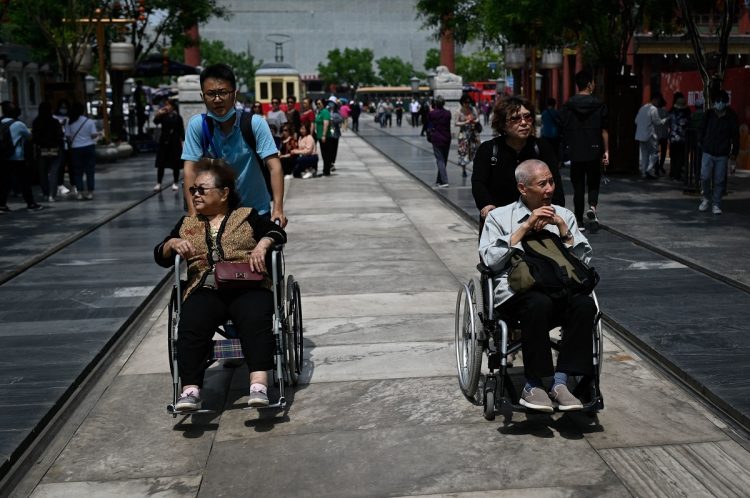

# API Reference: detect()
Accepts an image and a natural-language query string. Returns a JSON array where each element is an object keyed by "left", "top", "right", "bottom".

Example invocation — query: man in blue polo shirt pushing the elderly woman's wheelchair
[{"left": 182, "top": 64, "right": 287, "bottom": 226}]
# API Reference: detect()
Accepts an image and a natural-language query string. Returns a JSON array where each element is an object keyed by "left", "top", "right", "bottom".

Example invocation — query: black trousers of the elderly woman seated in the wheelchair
[{"left": 177, "top": 287, "right": 274, "bottom": 387}]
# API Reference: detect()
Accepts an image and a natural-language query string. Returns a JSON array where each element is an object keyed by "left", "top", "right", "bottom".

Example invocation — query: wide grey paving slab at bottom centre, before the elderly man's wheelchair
[{"left": 201, "top": 424, "right": 619, "bottom": 497}]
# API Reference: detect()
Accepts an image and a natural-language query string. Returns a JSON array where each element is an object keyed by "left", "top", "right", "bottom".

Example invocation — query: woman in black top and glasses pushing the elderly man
[{"left": 471, "top": 97, "right": 565, "bottom": 224}]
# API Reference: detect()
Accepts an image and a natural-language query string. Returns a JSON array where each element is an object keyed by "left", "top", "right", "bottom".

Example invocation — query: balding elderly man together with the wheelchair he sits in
[{"left": 457, "top": 159, "right": 603, "bottom": 419}]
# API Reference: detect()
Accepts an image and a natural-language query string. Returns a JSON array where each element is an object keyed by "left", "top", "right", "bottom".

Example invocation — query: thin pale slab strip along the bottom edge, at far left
[{"left": 31, "top": 475, "right": 202, "bottom": 498}]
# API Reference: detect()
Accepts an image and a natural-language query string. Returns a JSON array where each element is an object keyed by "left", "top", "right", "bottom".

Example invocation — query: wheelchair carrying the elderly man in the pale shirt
[{"left": 455, "top": 263, "right": 604, "bottom": 422}]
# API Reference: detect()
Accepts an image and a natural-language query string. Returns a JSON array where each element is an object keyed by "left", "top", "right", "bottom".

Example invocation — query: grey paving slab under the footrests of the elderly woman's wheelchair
[{"left": 42, "top": 369, "right": 226, "bottom": 484}]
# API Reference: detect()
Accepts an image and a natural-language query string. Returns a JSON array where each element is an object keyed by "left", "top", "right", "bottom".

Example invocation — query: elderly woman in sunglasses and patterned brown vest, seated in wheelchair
[{"left": 154, "top": 159, "right": 286, "bottom": 412}]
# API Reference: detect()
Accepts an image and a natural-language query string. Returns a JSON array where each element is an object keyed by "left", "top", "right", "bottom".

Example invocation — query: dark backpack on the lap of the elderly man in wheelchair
[{"left": 508, "top": 230, "right": 599, "bottom": 299}]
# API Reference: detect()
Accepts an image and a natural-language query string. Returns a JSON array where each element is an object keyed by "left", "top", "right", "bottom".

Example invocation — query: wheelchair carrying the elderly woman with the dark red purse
[{"left": 167, "top": 245, "right": 303, "bottom": 418}]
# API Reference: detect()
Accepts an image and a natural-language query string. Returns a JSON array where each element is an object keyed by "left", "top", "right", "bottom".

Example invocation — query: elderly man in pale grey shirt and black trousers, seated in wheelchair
[{"left": 479, "top": 159, "right": 601, "bottom": 412}]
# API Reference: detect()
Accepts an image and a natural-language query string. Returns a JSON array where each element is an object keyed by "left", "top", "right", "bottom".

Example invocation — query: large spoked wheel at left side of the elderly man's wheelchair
[{"left": 455, "top": 277, "right": 483, "bottom": 402}]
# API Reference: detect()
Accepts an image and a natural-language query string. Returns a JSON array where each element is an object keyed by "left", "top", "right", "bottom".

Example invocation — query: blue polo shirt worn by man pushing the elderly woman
[{"left": 182, "top": 111, "right": 278, "bottom": 214}]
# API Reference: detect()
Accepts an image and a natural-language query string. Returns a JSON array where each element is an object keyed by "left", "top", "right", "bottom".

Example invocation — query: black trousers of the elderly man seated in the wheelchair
[{"left": 498, "top": 290, "right": 596, "bottom": 379}]
